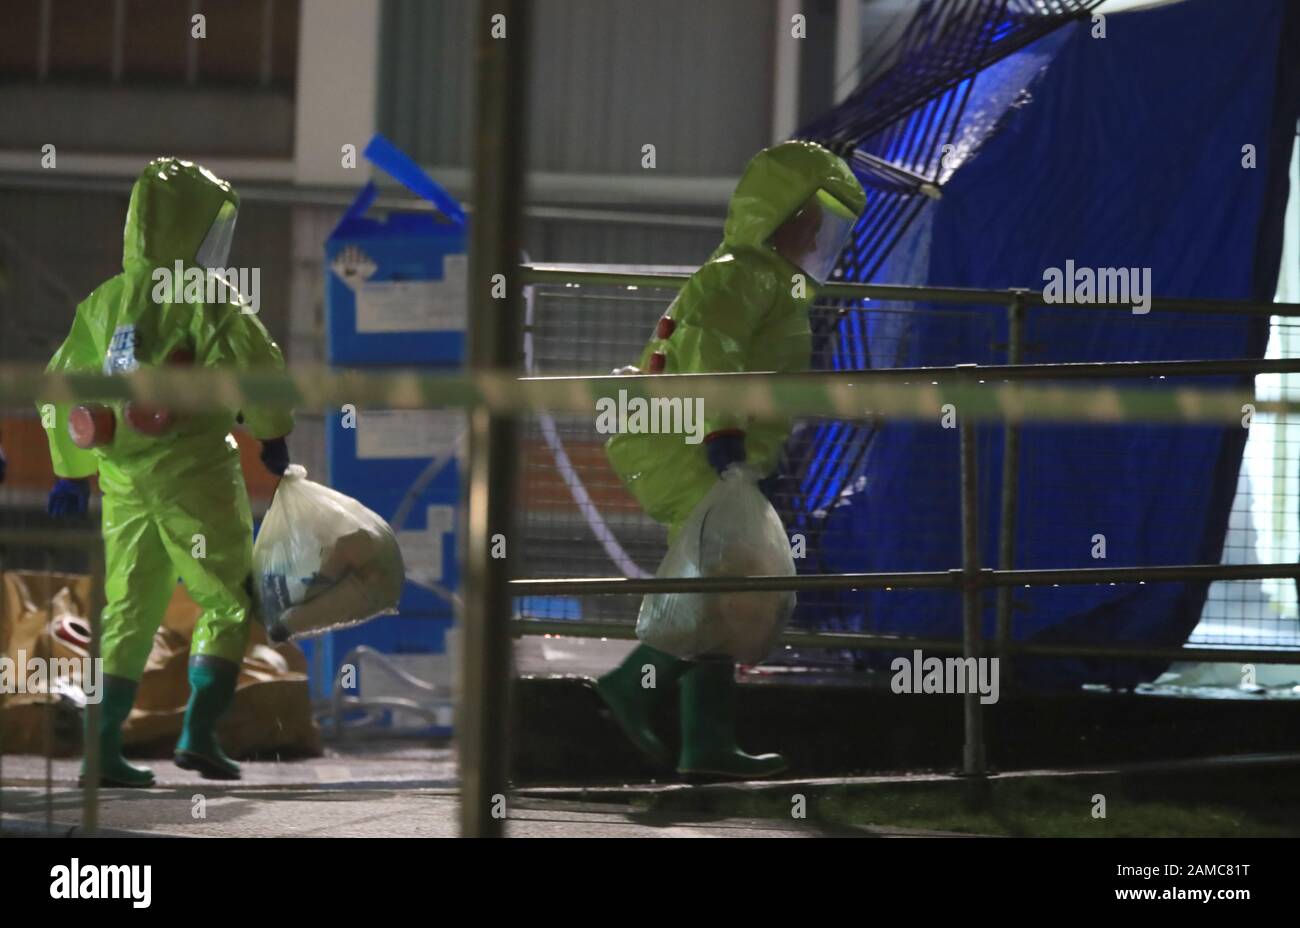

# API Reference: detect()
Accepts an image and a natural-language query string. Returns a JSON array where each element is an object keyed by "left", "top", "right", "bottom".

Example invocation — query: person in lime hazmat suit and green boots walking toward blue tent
[{"left": 595, "top": 142, "right": 866, "bottom": 779}]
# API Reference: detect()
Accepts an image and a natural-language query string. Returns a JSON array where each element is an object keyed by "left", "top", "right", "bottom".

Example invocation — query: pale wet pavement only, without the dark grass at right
[{"left": 0, "top": 741, "right": 880, "bottom": 837}]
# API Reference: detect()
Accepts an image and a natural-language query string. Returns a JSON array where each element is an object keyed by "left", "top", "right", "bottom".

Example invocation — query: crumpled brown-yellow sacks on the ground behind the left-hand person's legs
[{"left": 0, "top": 571, "right": 321, "bottom": 756}]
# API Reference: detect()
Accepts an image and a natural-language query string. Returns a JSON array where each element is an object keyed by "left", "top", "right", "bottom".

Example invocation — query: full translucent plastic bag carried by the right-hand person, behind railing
[{"left": 637, "top": 464, "right": 794, "bottom": 664}]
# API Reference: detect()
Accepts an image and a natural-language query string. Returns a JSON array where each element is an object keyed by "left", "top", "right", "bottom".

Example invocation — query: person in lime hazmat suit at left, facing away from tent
[{"left": 42, "top": 157, "right": 294, "bottom": 786}]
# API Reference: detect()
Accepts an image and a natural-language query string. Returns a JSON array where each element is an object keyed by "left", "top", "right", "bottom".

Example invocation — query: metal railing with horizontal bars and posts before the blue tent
[{"left": 510, "top": 264, "right": 1300, "bottom": 775}]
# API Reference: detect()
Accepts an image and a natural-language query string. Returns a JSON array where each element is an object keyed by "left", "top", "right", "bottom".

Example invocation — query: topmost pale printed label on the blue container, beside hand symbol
[{"left": 356, "top": 255, "right": 468, "bottom": 333}]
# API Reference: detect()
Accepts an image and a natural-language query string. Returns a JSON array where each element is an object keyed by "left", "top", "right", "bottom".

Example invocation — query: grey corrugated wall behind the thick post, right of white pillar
[{"left": 380, "top": 0, "right": 774, "bottom": 175}]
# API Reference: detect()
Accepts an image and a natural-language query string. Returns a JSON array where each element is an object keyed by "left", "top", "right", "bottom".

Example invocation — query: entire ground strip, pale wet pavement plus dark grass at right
[{"left": 0, "top": 741, "right": 1300, "bottom": 837}]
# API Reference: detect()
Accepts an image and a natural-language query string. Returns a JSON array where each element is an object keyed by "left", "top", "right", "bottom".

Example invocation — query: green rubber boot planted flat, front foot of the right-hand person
[{"left": 677, "top": 660, "right": 787, "bottom": 780}]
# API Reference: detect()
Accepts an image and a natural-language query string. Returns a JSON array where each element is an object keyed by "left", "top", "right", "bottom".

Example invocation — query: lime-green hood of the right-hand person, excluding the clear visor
[{"left": 723, "top": 142, "right": 867, "bottom": 250}]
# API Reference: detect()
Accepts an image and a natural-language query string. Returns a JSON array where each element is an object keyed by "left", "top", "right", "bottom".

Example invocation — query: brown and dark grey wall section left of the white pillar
[{"left": 0, "top": 0, "right": 299, "bottom": 157}]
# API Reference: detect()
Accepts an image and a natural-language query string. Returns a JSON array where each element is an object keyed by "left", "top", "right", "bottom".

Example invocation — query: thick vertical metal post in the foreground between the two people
[{"left": 456, "top": 0, "right": 528, "bottom": 837}]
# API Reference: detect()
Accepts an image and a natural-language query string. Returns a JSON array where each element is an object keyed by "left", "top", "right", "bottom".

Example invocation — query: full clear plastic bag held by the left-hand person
[{"left": 252, "top": 464, "right": 406, "bottom": 641}]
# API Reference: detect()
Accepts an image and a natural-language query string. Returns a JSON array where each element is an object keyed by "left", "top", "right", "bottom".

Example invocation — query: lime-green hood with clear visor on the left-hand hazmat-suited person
[{"left": 122, "top": 157, "right": 239, "bottom": 270}]
